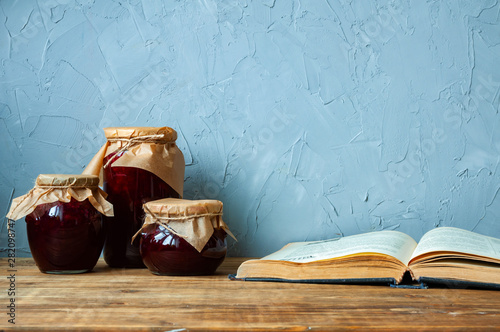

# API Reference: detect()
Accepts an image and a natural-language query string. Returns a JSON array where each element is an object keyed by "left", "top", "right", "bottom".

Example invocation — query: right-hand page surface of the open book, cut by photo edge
[{"left": 412, "top": 227, "right": 500, "bottom": 259}]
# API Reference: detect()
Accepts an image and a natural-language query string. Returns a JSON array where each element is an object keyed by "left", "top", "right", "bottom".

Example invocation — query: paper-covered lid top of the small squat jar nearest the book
[{"left": 144, "top": 198, "right": 222, "bottom": 219}]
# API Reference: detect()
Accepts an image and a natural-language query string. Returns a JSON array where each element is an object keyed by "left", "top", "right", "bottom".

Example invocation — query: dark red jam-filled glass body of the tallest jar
[{"left": 104, "top": 153, "right": 180, "bottom": 267}]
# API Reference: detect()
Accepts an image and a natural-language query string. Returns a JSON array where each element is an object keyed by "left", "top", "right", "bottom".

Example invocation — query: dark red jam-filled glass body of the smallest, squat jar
[{"left": 141, "top": 224, "right": 227, "bottom": 275}]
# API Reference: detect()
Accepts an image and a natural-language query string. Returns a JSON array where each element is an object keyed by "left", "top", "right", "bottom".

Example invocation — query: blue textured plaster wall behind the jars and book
[{"left": 0, "top": 0, "right": 500, "bottom": 256}]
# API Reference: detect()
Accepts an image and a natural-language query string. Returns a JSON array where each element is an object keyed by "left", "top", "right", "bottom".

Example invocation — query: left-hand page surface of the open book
[{"left": 262, "top": 231, "right": 417, "bottom": 264}]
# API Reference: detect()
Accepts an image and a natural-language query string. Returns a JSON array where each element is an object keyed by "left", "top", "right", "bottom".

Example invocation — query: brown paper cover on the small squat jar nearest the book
[{"left": 136, "top": 198, "right": 236, "bottom": 252}]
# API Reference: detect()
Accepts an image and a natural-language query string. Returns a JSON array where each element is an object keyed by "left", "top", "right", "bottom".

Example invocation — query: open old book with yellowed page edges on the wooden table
[{"left": 230, "top": 227, "right": 500, "bottom": 289}]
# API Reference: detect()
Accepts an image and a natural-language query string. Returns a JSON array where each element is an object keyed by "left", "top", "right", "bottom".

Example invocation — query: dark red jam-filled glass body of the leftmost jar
[{"left": 26, "top": 199, "right": 105, "bottom": 273}]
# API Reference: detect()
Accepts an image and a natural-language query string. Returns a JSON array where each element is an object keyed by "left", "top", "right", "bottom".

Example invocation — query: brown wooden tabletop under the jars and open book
[{"left": 0, "top": 258, "right": 500, "bottom": 331}]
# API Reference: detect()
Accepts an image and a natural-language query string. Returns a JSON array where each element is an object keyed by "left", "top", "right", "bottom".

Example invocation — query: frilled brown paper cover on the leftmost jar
[{"left": 7, "top": 174, "right": 113, "bottom": 220}]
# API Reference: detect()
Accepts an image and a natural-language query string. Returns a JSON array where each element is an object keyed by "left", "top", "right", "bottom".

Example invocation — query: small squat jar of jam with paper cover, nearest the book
[{"left": 138, "top": 198, "right": 234, "bottom": 275}]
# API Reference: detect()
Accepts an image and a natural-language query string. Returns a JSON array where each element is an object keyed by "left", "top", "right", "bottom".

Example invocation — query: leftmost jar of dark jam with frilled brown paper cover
[{"left": 7, "top": 174, "right": 113, "bottom": 274}]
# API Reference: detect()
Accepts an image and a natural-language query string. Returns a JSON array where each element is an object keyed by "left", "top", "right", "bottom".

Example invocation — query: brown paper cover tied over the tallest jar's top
[{"left": 83, "top": 127, "right": 185, "bottom": 197}]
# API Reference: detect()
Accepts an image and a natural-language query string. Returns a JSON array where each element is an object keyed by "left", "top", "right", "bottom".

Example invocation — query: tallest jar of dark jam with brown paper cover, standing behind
[{"left": 84, "top": 127, "right": 185, "bottom": 267}]
